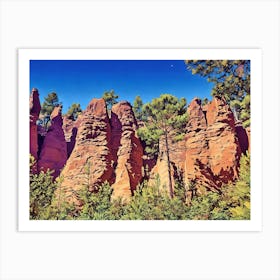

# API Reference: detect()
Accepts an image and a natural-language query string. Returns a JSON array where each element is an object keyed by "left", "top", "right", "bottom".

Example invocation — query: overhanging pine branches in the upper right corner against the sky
[{"left": 185, "top": 60, "right": 251, "bottom": 127}]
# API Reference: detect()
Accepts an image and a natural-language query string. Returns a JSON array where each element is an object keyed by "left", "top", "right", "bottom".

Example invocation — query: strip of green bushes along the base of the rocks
[{"left": 30, "top": 154, "right": 250, "bottom": 220}]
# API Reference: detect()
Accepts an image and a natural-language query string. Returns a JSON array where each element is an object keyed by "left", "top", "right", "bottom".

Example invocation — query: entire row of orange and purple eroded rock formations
[{"left": 30, "top": 92, "right": 250, "bottom": 205}]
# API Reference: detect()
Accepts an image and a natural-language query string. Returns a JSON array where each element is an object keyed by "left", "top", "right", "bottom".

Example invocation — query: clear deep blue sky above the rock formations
[{"left": 30, "top": 60, "right": 212, "bottom": 113}]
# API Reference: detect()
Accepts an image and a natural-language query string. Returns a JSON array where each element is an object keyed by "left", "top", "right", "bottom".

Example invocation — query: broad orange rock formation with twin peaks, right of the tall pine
[{"left": 185, "top": 98, "right": 241, "bottom": 190}]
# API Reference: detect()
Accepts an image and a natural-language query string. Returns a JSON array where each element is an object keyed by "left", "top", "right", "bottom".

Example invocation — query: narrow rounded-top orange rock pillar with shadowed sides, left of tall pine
[{"left": 111, "top": 101, "right": 143, "bottom": 199}]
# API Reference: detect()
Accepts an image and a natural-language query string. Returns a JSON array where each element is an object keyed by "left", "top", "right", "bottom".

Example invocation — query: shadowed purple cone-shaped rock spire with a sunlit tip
[{"left": 38, "top": 106, "right": 67, "bottom": 178}]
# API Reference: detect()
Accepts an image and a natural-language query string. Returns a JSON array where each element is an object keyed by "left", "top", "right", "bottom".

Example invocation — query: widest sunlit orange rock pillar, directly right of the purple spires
[{"left": 61, "top": 98, "right": 114, "bottom": 205}]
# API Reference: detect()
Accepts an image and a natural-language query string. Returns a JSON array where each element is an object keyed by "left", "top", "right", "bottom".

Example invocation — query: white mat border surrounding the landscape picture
[{"left": 18, "top": 49, "right": 262, "bottom": 231}]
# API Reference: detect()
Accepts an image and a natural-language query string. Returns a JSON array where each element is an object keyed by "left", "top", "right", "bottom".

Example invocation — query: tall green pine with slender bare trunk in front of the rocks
[{"left": 138, "top": 94, "right": 187, "bottom": 198}]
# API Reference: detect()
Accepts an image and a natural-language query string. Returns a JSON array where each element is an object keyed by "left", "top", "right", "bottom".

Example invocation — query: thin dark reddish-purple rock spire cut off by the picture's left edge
[{"left": 29, "top": 88, "right": 41, "bottom": 161}]
